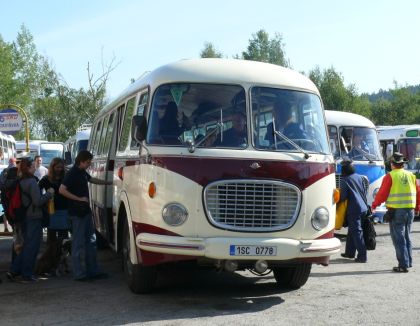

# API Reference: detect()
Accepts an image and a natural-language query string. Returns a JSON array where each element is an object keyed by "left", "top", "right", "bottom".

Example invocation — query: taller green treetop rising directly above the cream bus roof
[{"left": 242, "top": 29, "right": 290, "bottom": 67}]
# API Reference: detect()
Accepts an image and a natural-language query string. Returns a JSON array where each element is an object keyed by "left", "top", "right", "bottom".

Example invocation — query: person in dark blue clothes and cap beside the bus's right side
[{"left": 340, "top": 160, "right": 368, "bottom": 263}]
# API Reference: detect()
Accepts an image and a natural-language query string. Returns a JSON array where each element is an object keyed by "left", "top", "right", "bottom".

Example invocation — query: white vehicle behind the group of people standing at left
[{"left": 16, "top": 140, "right": 64, "bottom": 168}]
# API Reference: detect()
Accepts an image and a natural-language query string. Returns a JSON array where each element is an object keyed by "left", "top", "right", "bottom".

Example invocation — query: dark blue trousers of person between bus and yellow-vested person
[{"left": 345, "top": 213, "right": 367, "bottom": 260}]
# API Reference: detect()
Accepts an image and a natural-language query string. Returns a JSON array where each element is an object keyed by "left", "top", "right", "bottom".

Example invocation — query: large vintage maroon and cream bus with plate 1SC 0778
[{"left": 89, "top": 59, "right": 340, "bottom": 293}]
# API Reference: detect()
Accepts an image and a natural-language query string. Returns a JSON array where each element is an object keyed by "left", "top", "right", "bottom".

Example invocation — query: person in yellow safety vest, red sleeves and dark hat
[{"left": 372, "top": 152, "right": 420, "bottom": 273}]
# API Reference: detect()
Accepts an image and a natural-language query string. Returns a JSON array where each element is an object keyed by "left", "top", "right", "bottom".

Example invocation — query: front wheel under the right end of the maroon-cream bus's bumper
[{"left": 273, "top": 263, "right": 312, "bottom": 289}]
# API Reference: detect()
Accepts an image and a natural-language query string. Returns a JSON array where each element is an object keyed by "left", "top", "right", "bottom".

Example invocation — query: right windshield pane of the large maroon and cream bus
[{"left": 251, "top": 87, "right": 330, "bottom": 153}]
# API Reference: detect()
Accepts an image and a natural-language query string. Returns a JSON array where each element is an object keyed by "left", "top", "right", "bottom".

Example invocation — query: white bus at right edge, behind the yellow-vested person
[{"left": 377, "top": 125, "right": 420, "bottom": 179}]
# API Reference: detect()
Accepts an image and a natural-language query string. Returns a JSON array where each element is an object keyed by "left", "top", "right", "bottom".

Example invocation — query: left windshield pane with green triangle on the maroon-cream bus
[{"left": 146, "top": 83, "right": 248, "bottom": 149}]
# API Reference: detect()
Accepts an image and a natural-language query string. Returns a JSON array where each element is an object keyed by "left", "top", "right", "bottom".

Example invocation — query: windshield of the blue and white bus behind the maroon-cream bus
[{"left": 328, "top": 126, "right": 382, "bottom": 161}]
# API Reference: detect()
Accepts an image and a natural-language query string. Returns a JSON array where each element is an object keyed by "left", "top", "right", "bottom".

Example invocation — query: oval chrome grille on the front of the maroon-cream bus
[{"left": 204, "top": 180, "right": 301, "bottom": 231}]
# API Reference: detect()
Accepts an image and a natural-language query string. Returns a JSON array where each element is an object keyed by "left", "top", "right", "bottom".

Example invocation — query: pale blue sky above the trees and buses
[{"left": 0, "top": 0, "right": 420, "bottom": 97}]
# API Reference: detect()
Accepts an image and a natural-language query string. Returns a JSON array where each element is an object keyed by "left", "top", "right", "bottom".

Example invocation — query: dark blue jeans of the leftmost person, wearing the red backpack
[{"left": 10, "top": 217, "right": 42, "bottom": 277}]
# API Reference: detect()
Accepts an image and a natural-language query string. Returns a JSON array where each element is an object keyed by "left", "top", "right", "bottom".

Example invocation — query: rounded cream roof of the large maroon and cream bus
[{"left": 101, "top": 58, "right": 319, "bottom": 117}]
